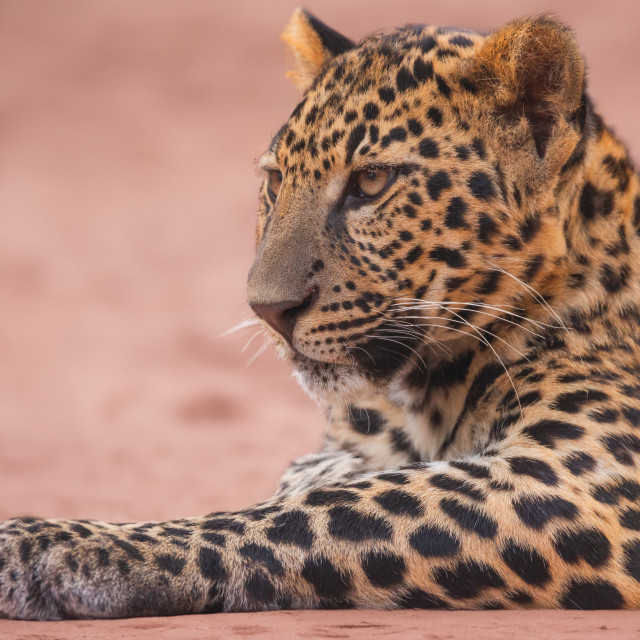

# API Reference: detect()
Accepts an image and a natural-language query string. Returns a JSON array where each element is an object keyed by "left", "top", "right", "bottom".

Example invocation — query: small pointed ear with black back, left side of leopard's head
[{"left": 282, "top": 8, "right": 355, "bottom": 92}]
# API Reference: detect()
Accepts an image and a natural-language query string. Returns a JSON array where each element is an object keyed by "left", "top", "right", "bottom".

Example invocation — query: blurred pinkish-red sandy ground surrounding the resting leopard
[{"left": 0, "top": 0, "right": 640, "bottom": 638}]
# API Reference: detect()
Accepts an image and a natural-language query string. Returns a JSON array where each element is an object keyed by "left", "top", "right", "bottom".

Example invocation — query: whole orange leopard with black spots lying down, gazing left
[{"left": 0, "top": 9, "right": 640, "bottom": 620}]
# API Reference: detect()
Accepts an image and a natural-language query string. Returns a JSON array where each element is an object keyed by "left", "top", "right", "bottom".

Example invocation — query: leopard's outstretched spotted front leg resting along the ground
[{"left": 0, "top": 447, "right": 640, "bottom": 619}]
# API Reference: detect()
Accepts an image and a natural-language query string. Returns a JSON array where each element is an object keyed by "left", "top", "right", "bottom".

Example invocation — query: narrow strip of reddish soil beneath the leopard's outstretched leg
[{"left": 6, "top": 610, "right": 640, "bottom": 640}]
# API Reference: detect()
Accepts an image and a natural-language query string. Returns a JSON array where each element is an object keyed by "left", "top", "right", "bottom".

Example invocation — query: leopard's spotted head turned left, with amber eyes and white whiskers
[{"left": 249, "top": 14, "right": 585, "bottom": 399}]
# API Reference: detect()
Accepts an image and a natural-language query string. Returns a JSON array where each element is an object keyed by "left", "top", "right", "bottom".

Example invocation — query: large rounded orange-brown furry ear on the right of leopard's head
[{"left": 471, "top": 16, "right": 585, "bottom": 158}]
